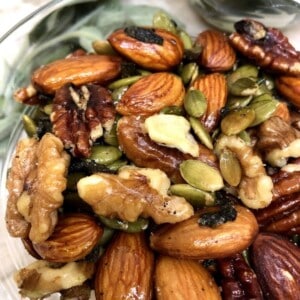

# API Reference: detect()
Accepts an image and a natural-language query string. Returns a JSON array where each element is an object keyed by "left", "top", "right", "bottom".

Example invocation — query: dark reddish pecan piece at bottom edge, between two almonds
[{"left": 217, "top": 253, "right": 263, "bottom": 300}]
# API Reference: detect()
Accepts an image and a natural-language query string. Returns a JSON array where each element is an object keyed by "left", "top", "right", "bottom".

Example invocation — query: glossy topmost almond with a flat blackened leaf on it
[{"left": 108, "top": 26, "right": 184, "bottom": 71}]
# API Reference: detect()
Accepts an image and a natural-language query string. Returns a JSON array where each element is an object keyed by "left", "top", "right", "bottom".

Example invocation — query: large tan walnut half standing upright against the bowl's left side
[{"left": 6, "top": 133, "right": 70, "bottom": 243}]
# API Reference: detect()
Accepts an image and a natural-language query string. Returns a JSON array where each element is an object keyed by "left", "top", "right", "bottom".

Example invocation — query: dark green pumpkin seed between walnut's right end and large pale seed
[{"left": 170, "top": 183, "right": 215, "bottom": 208}]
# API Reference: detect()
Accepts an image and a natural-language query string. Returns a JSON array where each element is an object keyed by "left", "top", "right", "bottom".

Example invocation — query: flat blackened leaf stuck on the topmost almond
[{"left": 124, "top": 26, "right": 164, "bottom": 45}]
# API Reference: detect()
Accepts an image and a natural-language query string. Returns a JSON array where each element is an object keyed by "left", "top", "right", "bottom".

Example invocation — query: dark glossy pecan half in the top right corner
[{"left": 229, "top": 19, "right": 300, "bottom": 76}]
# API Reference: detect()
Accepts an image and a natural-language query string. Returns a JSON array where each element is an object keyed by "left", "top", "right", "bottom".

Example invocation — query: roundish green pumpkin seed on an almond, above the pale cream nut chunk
[{"left": 183, "top": 89, "right": 207, "bottom": 118}]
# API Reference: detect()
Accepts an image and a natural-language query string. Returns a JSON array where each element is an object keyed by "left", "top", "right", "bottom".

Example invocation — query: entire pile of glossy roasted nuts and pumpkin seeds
[{"left": 6, "top": 12, "right": 300, "bottom": 300}]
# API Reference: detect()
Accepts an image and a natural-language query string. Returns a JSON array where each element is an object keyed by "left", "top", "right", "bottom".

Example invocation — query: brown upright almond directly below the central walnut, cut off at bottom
[{"left": 95, "top": 232, "right": 154, "bottom": 300}]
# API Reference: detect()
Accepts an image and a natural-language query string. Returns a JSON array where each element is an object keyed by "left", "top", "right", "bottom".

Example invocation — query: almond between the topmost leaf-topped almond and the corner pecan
[{"left": 196, "top": 29, "right": 236, "bottom": 72}]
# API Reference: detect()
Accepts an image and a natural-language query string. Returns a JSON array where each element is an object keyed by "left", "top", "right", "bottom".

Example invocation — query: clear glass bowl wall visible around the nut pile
[{"left": 0, "top": 0, "right": 300, "bottom": 300}]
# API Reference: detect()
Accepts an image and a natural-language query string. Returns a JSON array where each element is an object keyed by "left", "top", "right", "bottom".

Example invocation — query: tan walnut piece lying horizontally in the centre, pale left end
[{"left": 77, "top": 167, "right": 194, "bottom": 224}]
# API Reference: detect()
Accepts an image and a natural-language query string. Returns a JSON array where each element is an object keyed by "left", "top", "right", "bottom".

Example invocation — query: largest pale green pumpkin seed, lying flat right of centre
[{"left": 179, "top": 159, "right": 224, "bottom": 192}]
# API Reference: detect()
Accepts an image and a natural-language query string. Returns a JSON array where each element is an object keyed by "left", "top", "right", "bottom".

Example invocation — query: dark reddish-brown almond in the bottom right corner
[{"left": 251, "top": 233, "right": 300, "bottom": 300}]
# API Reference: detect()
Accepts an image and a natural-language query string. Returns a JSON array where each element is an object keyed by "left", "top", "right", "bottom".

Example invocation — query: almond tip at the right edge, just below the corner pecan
[{"left": 275, "top": 76, "right": 300, "bottom": 108}]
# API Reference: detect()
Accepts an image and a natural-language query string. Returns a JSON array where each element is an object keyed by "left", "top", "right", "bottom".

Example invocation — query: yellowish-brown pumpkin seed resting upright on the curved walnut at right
[{"left": 219, "top": 150, "right": 242, "bottom": 186}]
